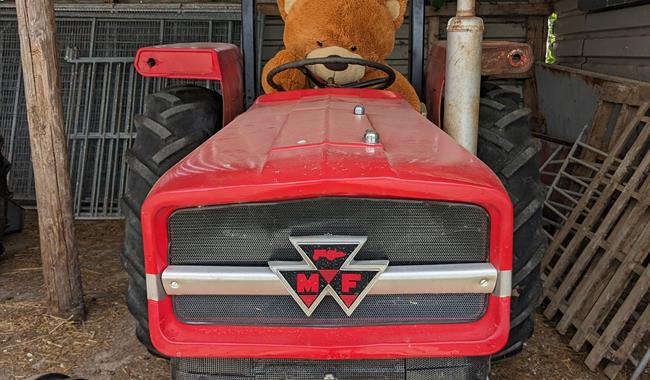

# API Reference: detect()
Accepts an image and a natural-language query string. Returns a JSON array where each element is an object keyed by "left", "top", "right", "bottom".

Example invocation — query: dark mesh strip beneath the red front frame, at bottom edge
[{"left": 171, "top": 357, "right": 489, "bottom": 380}]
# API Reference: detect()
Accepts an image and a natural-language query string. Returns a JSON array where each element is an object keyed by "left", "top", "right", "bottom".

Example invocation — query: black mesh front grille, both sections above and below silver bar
[{"left": 169, "top": 198, "right": 489, "bottom": 327}]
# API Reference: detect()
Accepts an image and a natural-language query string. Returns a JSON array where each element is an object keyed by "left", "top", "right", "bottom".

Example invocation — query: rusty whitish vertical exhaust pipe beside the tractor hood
[{"left": 443, "top": 0, "right": 483, "bottom": 154}]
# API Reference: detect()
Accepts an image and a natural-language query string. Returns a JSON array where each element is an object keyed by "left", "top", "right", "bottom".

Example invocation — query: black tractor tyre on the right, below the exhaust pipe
[{"left": 478, "top": 84, "right": 546, "bottom": 360}]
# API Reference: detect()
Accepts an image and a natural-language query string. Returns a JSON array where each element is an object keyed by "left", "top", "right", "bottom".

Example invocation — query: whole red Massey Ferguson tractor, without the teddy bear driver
[{"left": 124, "top": 0, "right": 544, "bottom": 380}]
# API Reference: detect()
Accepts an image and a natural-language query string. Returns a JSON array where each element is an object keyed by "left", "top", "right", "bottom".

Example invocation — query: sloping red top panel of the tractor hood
[{"left": 153, "top": 89, "right": 501, "bottom": 196}]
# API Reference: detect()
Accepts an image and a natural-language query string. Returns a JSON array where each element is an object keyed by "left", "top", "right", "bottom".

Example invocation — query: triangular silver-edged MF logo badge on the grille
[{"left": 269, "top": 235, "right": 388, "bottom": 316}]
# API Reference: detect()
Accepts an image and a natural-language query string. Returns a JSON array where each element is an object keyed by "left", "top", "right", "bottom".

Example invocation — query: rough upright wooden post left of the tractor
[{"left": 16, "top": 0, "right": 84, "bottom": 319}]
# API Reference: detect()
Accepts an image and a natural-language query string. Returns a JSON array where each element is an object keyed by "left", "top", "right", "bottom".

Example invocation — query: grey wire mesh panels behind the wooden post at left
[{"left": 0, "top": 4, "right": 241, "bottom": 218}]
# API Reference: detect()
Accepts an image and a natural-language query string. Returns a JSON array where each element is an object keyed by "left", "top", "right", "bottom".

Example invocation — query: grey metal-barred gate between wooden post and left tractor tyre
[{"left": 64, "top": 56, "right": 216, "bottom": 219}]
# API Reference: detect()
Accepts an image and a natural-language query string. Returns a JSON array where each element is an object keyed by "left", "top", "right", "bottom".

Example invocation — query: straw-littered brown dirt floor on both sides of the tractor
[{"left": 0, "top": 212, "right": 625, "bottom": 380}]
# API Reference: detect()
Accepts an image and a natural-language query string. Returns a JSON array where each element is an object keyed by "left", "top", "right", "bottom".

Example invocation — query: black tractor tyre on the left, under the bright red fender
[{"left": 122, "top": 86, "right": 222, "bottom": 356}]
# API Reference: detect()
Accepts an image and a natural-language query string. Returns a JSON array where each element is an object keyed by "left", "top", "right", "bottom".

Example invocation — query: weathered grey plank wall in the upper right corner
[{"left": 554, "top": 0, "right": 650, "bottom": 82}]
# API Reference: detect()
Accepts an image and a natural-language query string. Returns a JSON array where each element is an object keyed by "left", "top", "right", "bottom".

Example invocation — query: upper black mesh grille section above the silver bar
[{"left": 169, "top": 198, "right": 489, "bottom": 266}]
